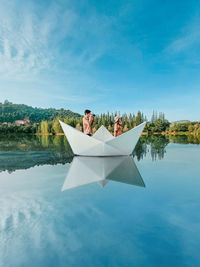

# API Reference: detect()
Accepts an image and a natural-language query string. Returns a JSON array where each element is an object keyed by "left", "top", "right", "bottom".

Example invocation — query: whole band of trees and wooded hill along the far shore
[{"left": 0, "top": 100, "right": 200, "bottom": 140}]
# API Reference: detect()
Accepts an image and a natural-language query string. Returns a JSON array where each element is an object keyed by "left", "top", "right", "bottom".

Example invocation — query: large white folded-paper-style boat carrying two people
[{"left": 60, "top": 121, "right": 146, "bottom": 156}]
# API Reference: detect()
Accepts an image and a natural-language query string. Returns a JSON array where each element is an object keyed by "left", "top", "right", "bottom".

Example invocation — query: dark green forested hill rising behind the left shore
[{"left": 0, "top": 100, "right": 81, "bottom": 123}]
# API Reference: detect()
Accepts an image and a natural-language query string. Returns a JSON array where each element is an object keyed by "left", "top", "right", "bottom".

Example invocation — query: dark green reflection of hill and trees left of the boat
[{"left": 0, "top": 134, "right": 73, "bottom": 172}]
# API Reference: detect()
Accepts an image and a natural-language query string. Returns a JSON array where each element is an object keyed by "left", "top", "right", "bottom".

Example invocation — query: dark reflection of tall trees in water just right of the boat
[{"left": 134, "top": 135, "right": 169, "bottom": 160}]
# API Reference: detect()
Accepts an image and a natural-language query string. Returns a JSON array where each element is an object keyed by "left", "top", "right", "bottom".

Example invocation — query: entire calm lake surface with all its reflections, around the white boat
[{"left": 0, "top": 136, "right": 200, "bottom": 267}]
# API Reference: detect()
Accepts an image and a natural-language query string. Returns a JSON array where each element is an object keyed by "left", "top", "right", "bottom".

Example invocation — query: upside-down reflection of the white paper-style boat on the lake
[{"left": 62, "top": 156, "right": 145, "bottom": 191}]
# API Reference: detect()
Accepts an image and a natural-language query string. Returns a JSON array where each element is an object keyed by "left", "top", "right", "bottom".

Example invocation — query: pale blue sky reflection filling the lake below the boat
[{"left": 0, "top": 144, "right": 200, "bottom": 266}]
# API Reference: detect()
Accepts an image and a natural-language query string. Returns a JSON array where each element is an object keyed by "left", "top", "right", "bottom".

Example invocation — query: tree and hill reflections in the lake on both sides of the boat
[{"left": 0, "top": 134, "right": 200, "bottom": 172}]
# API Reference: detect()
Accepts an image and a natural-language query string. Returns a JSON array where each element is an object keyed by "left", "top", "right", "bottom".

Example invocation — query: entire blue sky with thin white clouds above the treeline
[{"left": 0, "top": 0, "right": 200, "bottom": 121}]
